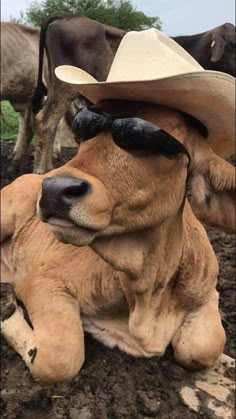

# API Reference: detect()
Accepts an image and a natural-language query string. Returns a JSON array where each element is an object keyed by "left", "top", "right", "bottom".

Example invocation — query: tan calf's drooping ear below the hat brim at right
[{"left": 189, "top": 150, "right": 235, "bottom": 233}]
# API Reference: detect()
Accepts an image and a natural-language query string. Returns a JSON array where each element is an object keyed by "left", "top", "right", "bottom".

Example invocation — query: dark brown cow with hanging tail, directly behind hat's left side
[{"left": 33, "top": 15, "right": 126, "bottom": 173}]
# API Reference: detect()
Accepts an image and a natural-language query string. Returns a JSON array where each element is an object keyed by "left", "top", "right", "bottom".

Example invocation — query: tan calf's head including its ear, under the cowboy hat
[{"left": 38, "top": 101, "right": 234, "bottom": 253}]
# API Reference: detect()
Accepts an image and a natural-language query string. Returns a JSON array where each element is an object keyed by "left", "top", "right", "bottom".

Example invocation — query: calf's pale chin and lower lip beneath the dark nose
[{"left": 47, "top": 217, "right": 97, "bottom": 246}]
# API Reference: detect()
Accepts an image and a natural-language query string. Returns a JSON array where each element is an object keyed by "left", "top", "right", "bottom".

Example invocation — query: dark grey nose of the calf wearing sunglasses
[{"left": 39, "top": 176, "right": 91, "bottom": 221}]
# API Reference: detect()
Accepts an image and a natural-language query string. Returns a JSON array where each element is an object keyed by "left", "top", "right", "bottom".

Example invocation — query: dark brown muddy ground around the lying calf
[{"left": 0, "top": 142, "right": 236, "bottom": 419}]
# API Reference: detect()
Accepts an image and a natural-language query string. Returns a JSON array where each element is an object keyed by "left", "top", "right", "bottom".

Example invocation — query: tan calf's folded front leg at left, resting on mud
[{"left": 3, "top": 275, "right": 84, "bottom": 382}]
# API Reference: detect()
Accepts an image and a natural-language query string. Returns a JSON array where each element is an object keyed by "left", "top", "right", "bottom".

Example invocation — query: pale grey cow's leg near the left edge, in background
[{"left": 10, "top": 106, "right": 34, "bottom": 167}]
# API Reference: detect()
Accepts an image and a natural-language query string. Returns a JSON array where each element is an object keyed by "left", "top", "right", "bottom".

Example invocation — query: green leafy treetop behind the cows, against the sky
[{"left": 22, "top": 0, "right": 161, "bottom": 31}]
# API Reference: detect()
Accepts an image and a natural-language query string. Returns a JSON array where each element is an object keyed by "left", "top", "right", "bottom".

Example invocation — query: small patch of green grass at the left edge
[{"left": 0, "top": 100, "right": 18, "bottom": 141}]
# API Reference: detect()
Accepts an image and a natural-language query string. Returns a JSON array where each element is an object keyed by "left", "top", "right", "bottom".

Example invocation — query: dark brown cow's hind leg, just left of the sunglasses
[{"left": 34, "top": 87, "right": 74, "bottom": 174}]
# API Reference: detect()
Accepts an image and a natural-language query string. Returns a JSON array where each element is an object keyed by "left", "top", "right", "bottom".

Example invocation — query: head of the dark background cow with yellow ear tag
[{"left": 211, "top": 23, "right": 236, "bottom": 77}]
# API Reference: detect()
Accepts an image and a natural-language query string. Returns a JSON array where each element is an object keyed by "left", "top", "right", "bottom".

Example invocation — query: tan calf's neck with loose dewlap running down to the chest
[{"left": 92, "top": 214, "right": 184, "bottom": 338}]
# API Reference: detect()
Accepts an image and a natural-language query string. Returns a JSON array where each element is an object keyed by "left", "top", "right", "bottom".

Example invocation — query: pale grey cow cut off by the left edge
[{"left": 1, "top": 22, "right": 47, "bottom": 162}]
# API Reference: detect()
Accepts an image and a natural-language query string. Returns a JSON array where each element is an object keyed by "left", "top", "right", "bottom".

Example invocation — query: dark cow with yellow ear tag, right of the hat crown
[{"left": 172, "top": 23, "right": 236, "bottom": 77}]
